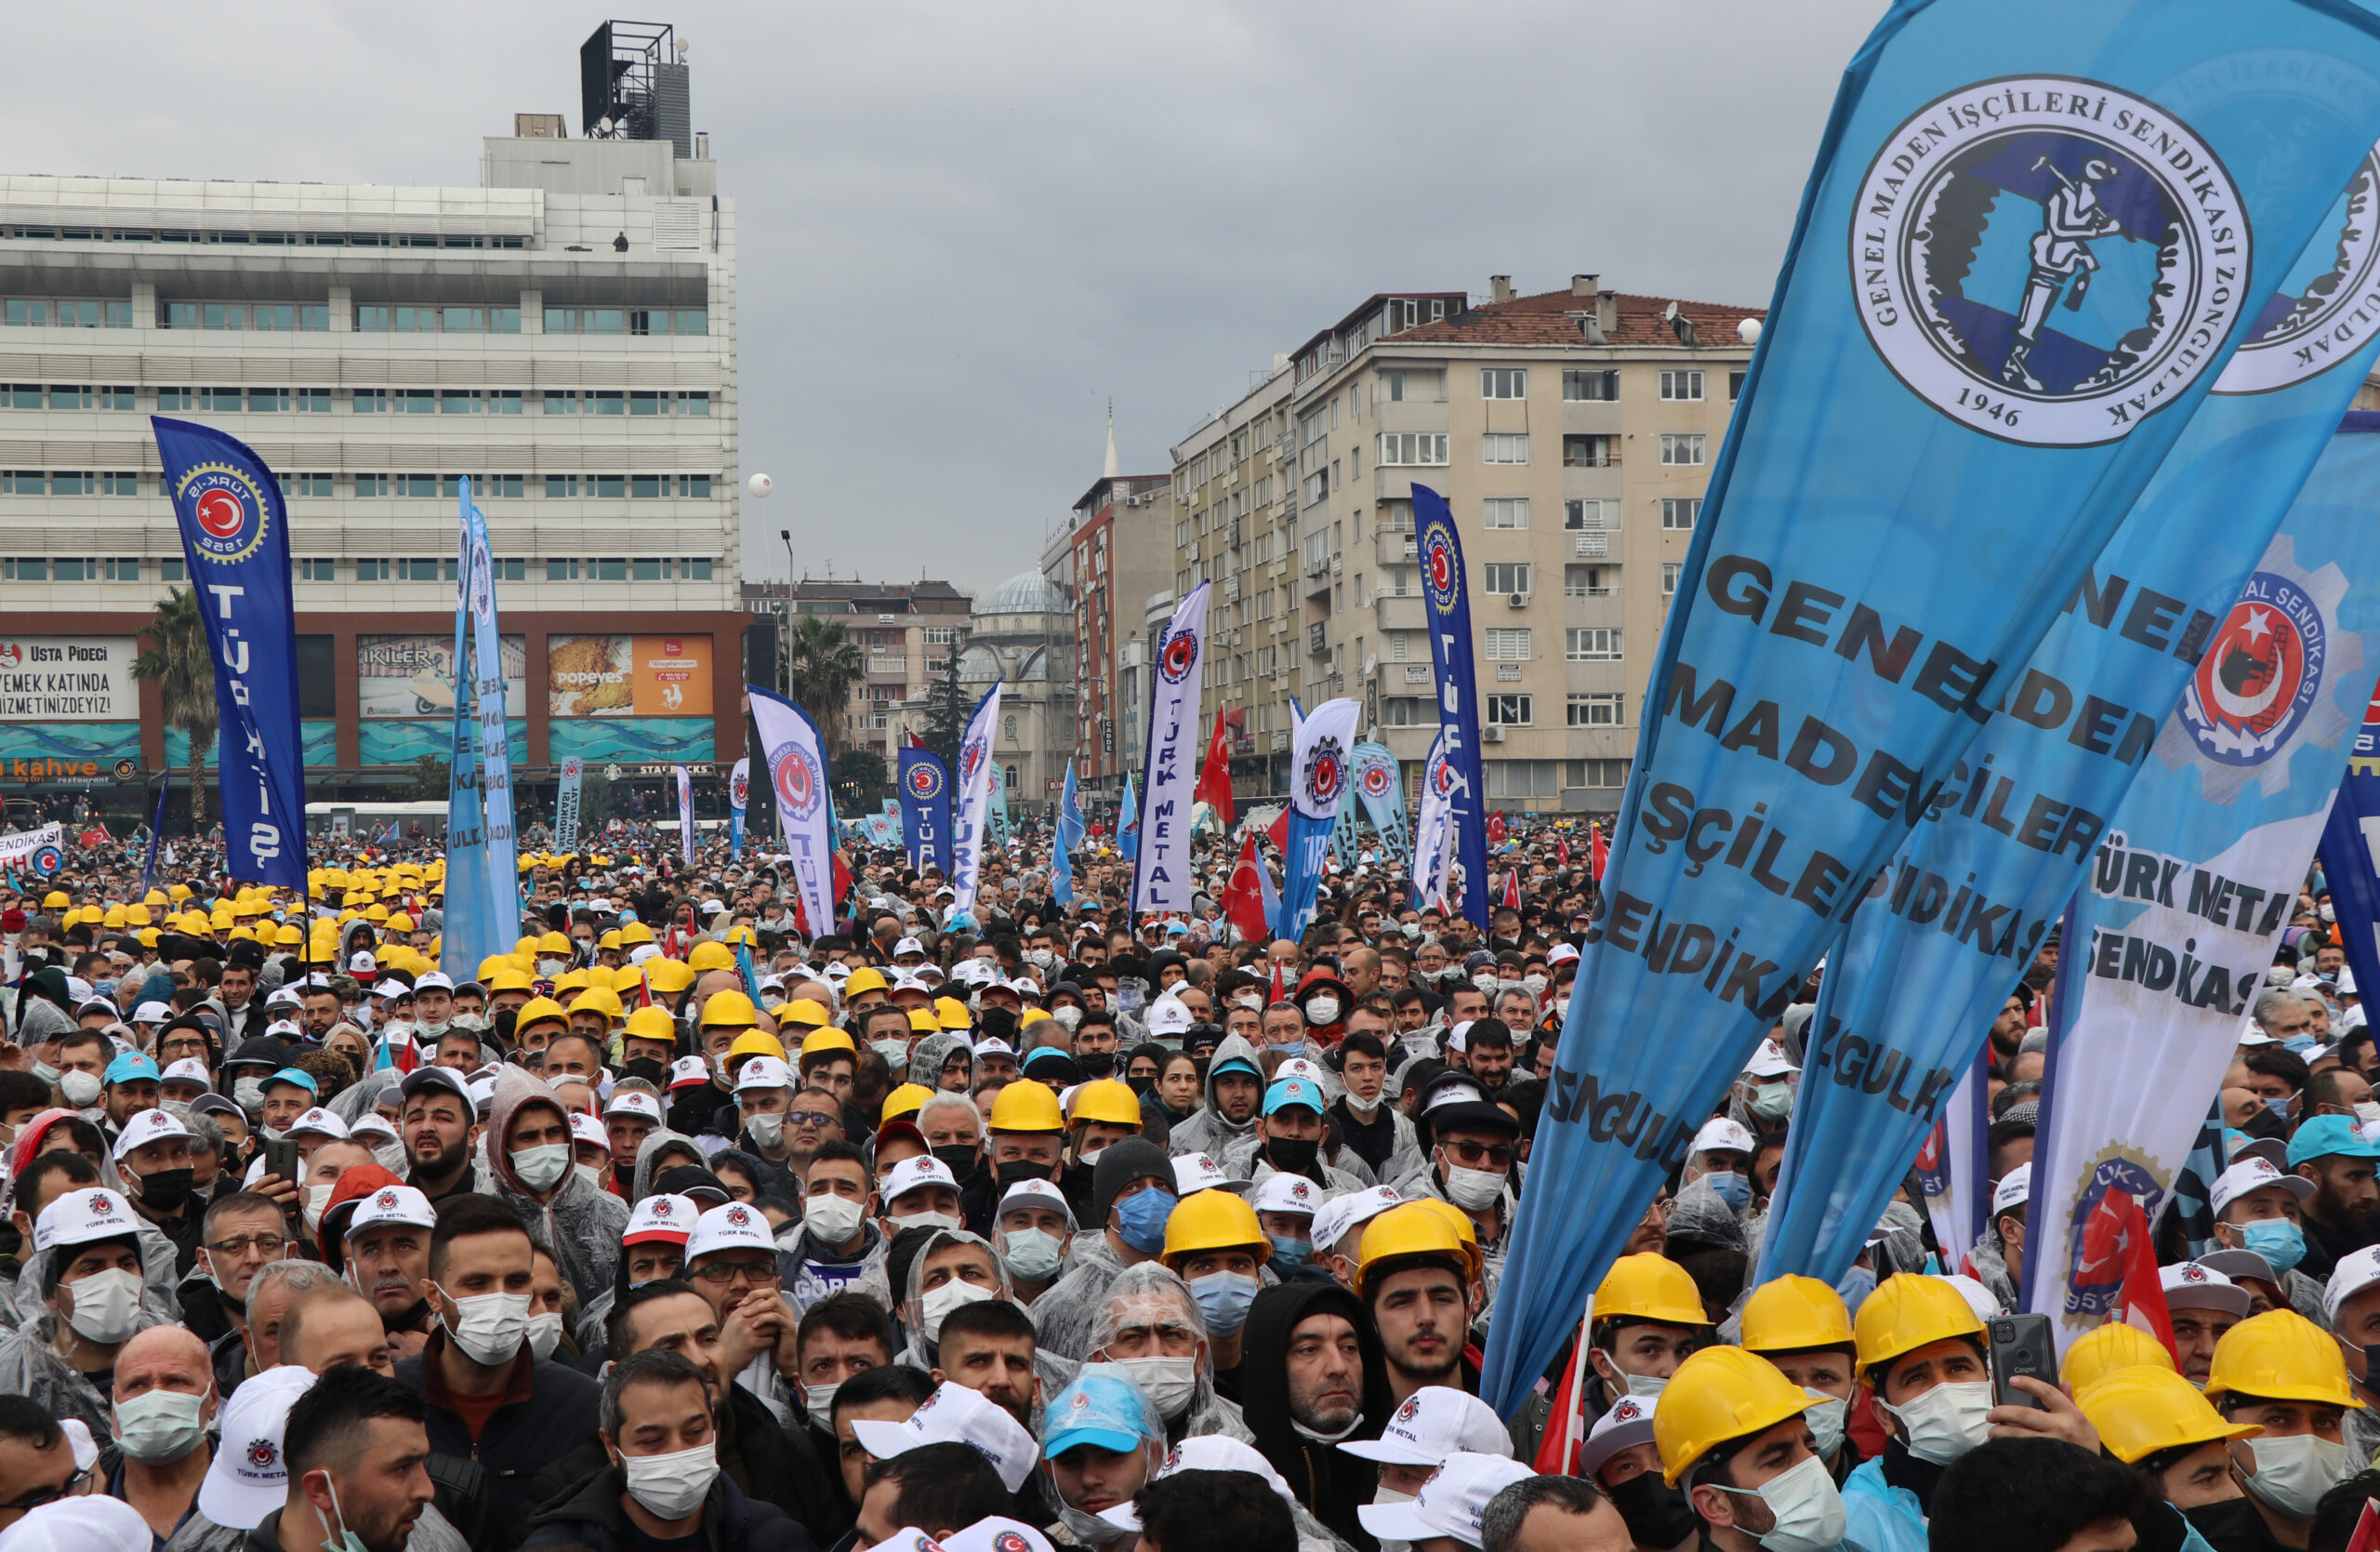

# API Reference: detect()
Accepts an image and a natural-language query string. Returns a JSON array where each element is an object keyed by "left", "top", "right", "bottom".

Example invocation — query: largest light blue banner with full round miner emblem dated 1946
[{"left": 1475, "top": 0, "right": 2380, "bottom": 1412}]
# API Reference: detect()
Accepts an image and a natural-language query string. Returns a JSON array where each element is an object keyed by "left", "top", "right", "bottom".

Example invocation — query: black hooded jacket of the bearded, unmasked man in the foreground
[{"left": 1240, "top": 1283, "right": 1393, "bottom": 1552}]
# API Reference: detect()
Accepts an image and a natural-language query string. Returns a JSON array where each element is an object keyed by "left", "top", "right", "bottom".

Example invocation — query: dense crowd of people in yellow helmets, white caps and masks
[{"left": 0, "top": 824, "right": 2380, "bottom": 1552}]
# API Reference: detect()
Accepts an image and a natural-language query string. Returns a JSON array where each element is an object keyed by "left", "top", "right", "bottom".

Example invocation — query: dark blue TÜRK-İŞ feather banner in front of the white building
[{"left": 150, "top": 414, "right": 305, "bottom": 893}]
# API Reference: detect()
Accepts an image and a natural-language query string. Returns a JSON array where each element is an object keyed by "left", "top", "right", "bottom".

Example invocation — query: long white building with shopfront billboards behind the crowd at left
[{"left": 0, "top": 114, "right": 745, "bottom": 812}]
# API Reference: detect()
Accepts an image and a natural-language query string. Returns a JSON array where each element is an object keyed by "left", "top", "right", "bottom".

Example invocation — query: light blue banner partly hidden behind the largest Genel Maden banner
[{"left": 1761, "top": 141, "right": 2380, "bottom": 1283}]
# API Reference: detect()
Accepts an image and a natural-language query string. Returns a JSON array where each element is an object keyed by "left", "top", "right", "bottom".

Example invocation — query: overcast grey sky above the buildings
[{"left": 14, "top": 0, "right": 1883, "bottom": 590}]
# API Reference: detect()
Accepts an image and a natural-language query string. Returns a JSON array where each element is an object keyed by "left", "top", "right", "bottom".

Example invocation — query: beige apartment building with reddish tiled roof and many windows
[{"left": 1176, "top": 273, "right": 1761, "bottom": 812}]
